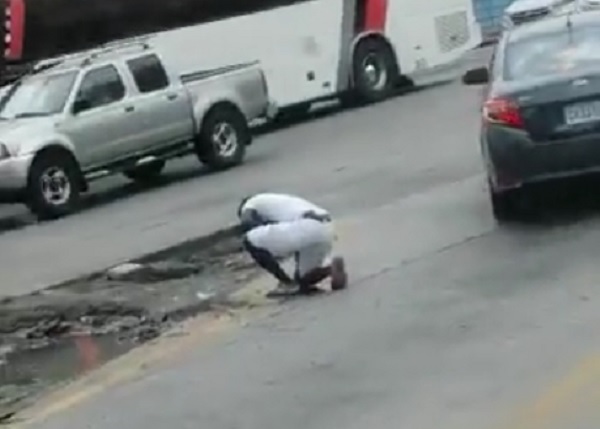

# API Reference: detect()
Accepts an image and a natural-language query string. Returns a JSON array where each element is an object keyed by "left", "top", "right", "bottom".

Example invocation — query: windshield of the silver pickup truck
[{"left": 0, "top": 72, "right": 77, "bottom": 119}]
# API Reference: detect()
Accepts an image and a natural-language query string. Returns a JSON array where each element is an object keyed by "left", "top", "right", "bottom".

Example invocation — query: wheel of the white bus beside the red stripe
[{"left": 352, "top": 39, "right": 398, "bottom": 103}]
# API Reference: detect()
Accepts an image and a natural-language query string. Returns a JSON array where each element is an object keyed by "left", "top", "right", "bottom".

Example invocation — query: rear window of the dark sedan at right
[{"left": 504, "top": 23, "right": 600, "bottom": 80}]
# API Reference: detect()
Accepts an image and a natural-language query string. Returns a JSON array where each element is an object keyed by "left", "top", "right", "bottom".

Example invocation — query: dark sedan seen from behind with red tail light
[{"left": 463, "top": 12, "right": 600, "bottom": 220}]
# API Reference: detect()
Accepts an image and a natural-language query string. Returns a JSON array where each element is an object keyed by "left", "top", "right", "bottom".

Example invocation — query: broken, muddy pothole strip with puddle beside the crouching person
[{"left": 0, "top": 229, "right": 258, "bottom": 422}]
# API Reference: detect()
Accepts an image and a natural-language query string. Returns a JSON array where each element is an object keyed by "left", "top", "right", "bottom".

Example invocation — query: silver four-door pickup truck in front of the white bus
[{"left": 0, "top": 43, "right": 270, "bottom": 219}]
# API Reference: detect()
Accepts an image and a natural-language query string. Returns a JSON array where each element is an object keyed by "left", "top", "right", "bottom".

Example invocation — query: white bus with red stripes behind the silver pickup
[{"left": 3, "top": 0, "right": 481, "bottom": 110}]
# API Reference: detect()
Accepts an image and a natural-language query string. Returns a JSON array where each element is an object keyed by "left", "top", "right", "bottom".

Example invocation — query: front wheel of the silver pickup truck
[{"left": 26, "top": 151, "right": 81, "bottom": 220}]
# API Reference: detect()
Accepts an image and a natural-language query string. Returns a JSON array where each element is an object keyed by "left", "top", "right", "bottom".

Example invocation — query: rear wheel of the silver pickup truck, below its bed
[{"left": 196, "top": 104, "right": 252, "bottom": 170}]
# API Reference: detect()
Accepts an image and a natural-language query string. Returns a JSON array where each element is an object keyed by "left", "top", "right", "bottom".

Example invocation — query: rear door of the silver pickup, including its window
[{"left": 126, "top": 54, "right": 194, "bottom": 149}]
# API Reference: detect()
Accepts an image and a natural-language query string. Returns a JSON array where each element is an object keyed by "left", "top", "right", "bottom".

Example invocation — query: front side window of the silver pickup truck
[{"left": 76, "top": 66, "right": 125, "bottom": 110}]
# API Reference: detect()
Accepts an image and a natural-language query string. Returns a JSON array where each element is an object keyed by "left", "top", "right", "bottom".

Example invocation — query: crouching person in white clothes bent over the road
[{"left": 238, "top": 193, "right": 348, "bottom": 296}]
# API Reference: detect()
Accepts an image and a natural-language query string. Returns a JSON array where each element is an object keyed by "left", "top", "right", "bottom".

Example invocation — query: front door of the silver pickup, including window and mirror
[{"left": 61, "top": 64, "right": 143, "bottom": 170}]
